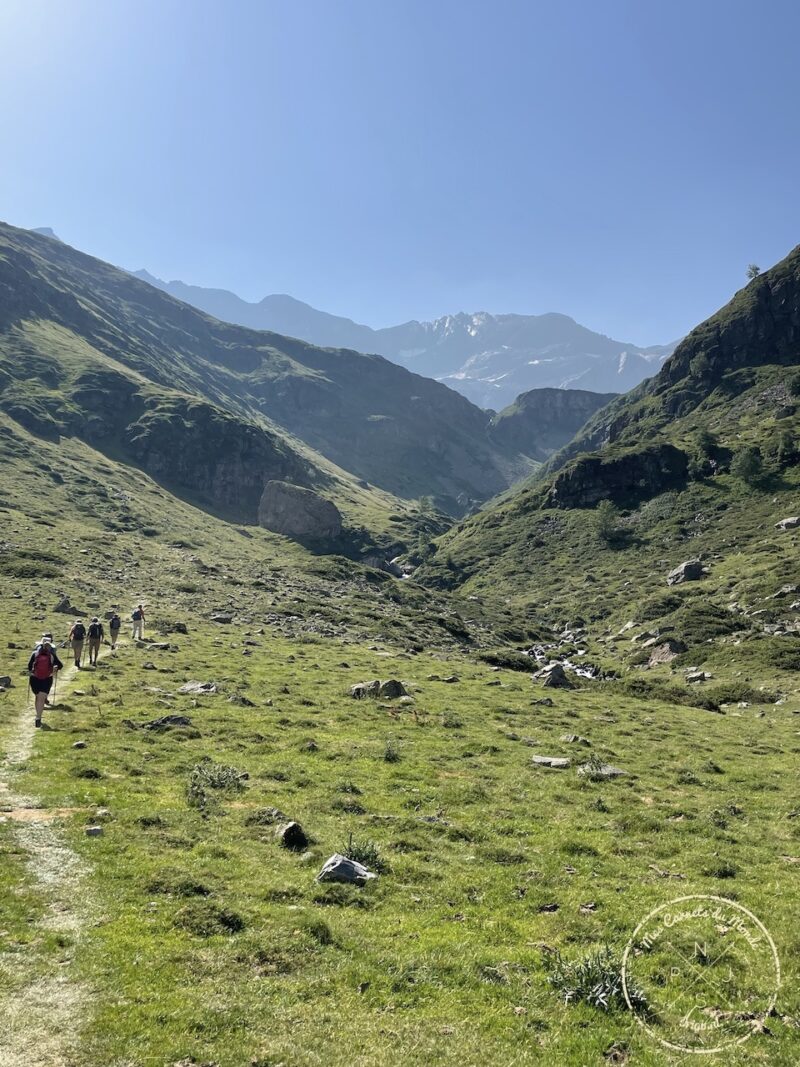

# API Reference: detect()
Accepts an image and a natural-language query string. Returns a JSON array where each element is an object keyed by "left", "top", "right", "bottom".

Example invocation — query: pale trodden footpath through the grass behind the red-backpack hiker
[{"left": 0, "top": 653, "right": 105, "bottom": 1067}]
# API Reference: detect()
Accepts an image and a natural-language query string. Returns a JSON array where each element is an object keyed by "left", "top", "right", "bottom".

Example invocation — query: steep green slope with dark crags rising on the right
[{"left": 420, "top": 248, "right": 800, "bottom": 648}]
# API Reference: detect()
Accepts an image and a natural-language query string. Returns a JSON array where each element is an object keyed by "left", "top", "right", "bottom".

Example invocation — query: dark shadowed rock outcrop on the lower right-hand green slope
[{"left": 544, "top": 444, "right": 688, "bottom": 508}]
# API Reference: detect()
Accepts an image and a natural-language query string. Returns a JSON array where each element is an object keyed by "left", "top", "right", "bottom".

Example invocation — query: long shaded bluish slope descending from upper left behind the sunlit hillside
[{"left": 0, "top": 219, "right": 546, "bottom": 513}]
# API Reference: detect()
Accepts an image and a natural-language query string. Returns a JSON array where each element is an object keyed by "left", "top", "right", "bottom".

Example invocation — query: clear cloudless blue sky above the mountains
[{"left": 0, "top": 0, "right": 800, "bottom": 344}]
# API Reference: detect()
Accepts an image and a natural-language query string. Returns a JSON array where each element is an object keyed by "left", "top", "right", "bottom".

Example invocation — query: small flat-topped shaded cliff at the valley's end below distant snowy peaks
[{"left": 489, "top": 389, "right": 617, "bottom": 461}]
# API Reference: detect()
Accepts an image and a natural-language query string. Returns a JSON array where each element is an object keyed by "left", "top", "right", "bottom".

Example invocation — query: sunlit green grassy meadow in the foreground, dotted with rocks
[{"left": 0, "top": 618, "right": 800, "bottom": 1067}]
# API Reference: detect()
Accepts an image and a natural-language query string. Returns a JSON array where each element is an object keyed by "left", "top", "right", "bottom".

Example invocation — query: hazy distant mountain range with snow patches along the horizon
[{"left": 135, "top": 271, "right": 675, "bottom": 410}]
